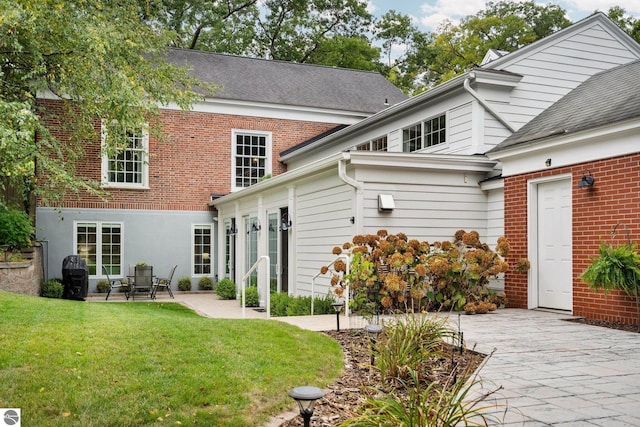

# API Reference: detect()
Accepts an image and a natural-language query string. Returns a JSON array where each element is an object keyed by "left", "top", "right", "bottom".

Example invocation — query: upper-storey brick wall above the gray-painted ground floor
[{"left": 39, "top": 100, "right": 337, "bottom": 211}]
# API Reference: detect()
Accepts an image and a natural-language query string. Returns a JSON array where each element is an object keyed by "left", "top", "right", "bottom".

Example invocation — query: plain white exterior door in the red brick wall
[{"left": 537, "top": 179, "right": 573, "bottom": 310}]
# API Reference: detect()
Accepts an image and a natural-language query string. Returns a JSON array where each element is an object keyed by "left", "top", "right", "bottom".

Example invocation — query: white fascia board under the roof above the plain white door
[{"left": 486, "top": 119, "right": 640, "bottom": 176}]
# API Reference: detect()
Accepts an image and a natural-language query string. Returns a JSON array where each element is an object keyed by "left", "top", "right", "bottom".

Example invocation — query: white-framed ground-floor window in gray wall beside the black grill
[{"left": 73, "top": 221, "right": 123, "bottom": 276}]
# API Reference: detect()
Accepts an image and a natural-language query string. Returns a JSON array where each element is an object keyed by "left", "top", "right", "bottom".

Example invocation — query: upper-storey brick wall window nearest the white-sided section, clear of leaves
[{"left": 232, "top": 130, "right": 271, "bottom": 189}]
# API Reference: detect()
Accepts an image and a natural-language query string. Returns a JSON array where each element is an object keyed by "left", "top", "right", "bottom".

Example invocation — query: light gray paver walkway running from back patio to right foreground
[{"left": 91, "top": 293, "right": 640, "bottom": 427}]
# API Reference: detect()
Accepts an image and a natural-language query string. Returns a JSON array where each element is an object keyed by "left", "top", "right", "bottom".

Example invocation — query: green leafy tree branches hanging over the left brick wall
[{"left": 0, "top": 0, "right": 212, "bottom": 204}]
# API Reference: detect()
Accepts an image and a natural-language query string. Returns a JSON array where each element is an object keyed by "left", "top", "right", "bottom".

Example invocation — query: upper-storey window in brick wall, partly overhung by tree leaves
[{"left": 102, "top": 125, "right": 149, "bottom": 188}]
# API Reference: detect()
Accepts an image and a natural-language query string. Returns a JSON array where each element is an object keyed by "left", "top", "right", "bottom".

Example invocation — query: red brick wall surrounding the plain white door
[{"left": 504, "top": 154, "right": 640, "bottom": 324}]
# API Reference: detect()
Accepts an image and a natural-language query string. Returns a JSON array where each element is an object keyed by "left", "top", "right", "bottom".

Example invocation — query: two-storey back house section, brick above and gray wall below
[{"left": 36, "top": 49, "right": 407, "bottom": 292}]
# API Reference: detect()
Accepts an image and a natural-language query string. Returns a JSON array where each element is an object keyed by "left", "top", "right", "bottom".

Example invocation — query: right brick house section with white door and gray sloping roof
[{"left": 487, "top": 61, "right": 640, "bottom": 324}]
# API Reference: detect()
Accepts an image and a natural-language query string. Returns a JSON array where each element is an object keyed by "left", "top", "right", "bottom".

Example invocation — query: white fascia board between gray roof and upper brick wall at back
[{"left": 160, "top": 98, "right": 369, "bottom": 124}]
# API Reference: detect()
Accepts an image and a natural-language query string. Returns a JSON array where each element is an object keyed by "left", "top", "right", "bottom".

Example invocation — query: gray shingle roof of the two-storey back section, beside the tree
[{"left": 168, "top": 49, "right": 407, "bottom": 114}]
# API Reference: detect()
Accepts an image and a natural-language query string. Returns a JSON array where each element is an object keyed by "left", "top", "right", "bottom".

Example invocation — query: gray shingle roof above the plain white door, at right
[{"left": 489, "top": 61, "right": 640, "bottom": 153}]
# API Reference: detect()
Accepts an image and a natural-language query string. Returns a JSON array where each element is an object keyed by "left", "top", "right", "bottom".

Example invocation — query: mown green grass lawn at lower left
[{"left": 0, "top": 291, "right": 343, "bottom": 427}]
